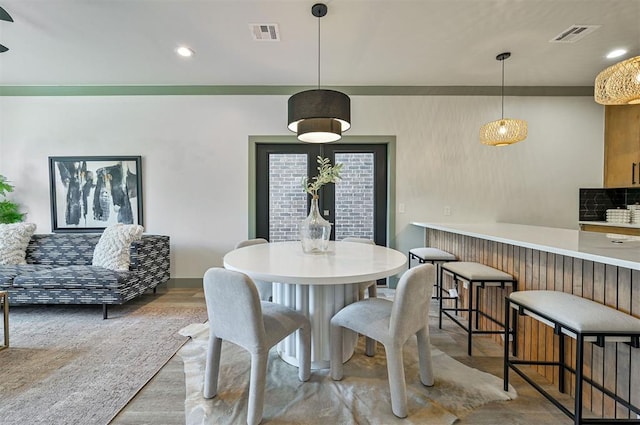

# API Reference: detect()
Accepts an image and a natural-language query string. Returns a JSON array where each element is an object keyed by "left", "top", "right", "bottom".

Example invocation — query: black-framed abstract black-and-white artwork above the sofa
[{"left": 49, "top": 156, "right": 143, "bottom": 233}]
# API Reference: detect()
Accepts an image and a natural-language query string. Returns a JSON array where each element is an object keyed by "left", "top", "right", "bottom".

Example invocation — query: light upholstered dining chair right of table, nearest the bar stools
[{"left": 331, "top": 264, "right": 435, "bottom": 418}]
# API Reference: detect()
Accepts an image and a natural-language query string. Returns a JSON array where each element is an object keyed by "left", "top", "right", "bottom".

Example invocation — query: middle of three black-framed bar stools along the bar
[{"left": 438, "top": 261, "right": 518, "bottom": 355}]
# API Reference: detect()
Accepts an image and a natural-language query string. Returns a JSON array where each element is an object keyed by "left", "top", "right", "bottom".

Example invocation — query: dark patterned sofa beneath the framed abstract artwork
[{"left": 0, "top": 233, "right": 169, "bottom": 319}]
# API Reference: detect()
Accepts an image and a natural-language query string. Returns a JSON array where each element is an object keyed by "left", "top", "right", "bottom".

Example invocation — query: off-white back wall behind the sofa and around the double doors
[{"left": 0, "top": 96, "right": 603, "bottom": 278}]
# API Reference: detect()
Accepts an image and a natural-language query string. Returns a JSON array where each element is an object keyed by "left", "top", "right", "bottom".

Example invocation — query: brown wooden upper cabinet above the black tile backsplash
[{"left": 604, "top": 105, "right": 640, "bottom": 187}]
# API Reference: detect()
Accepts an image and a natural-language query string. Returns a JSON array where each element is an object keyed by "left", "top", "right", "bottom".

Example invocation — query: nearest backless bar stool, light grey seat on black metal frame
[{"left": 504, "top": 290, "right": 640, "bottom": 425}]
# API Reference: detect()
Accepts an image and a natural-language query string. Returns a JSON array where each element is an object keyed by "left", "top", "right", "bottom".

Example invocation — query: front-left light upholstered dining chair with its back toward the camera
[{"left": 203, "top": 267, "right": 311, "bottom": 425}]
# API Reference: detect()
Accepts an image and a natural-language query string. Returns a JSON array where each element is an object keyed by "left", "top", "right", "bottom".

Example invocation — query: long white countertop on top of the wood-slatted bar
[{"left": 411, "top": 222, "right": 640, "bottom": 270}]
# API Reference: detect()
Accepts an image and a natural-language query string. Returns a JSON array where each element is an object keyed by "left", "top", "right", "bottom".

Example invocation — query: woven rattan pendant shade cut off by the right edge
[{"left": 593, "top": 56, "right": 640, "bottom": 105}]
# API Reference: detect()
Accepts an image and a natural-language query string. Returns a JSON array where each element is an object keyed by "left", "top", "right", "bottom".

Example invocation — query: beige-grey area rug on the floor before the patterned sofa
[{"left": 0, "top": 295, "right": 206, "bottom": 425}]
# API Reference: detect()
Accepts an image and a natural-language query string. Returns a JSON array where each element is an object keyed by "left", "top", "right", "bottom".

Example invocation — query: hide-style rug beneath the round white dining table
[{"left": 178, "top": 323, "right": 517, "bottom": 425}]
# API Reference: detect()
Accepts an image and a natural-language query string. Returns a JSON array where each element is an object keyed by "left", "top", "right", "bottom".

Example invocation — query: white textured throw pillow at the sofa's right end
[{"left": 92, "top": 224, "right": 144, "bottom": 270}]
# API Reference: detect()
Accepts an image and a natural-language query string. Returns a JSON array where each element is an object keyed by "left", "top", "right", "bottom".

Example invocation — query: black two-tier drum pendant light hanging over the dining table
[{"left": 287, "top": 3, "right": 351, "bottom": 143}]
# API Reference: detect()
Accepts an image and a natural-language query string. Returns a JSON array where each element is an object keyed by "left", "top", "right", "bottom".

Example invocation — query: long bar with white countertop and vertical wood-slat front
[{"left": 412, "top": 222, "right": 640, "bottom": 419}]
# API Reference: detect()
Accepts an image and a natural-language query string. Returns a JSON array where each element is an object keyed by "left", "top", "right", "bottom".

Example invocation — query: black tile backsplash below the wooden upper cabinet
[{"left": 578, "top": 188, "right": 640, "bottom": 221}]
